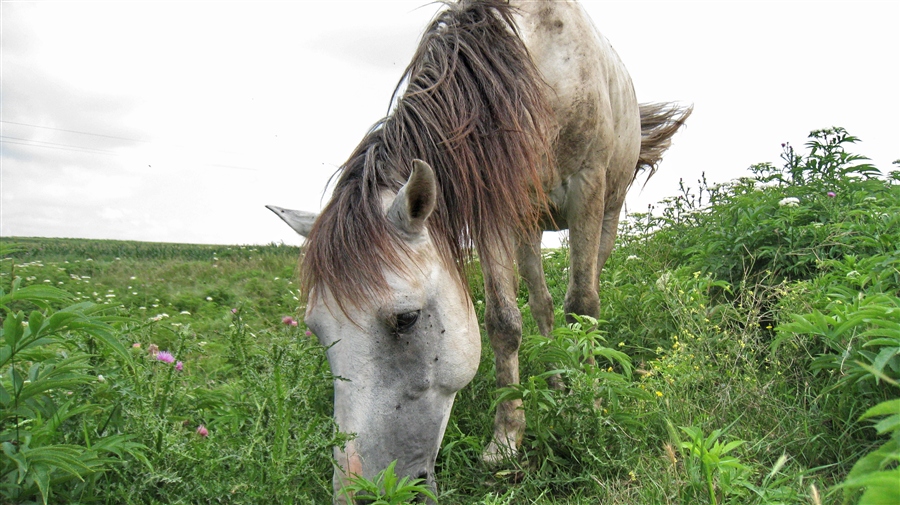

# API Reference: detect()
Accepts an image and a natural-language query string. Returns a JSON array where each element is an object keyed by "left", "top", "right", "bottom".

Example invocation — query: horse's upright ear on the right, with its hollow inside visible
[{"left": 387, "top": 160, "right": 437, "bottom": 235}]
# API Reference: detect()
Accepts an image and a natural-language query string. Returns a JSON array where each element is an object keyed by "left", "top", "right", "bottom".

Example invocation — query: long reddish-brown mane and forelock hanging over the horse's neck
[{"left": 301, "top": 0, "right": 556, "bottom": 313}]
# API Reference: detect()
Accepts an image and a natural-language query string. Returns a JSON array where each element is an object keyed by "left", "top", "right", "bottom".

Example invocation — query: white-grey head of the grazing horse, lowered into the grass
[{"left": 270, "top": 160, "right": 481, "bottom": 503}]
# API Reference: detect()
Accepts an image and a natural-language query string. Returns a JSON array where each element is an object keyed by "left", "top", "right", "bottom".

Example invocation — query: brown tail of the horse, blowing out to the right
[{"left": 634, "top": 102, "right": 694, "bottom": 183}]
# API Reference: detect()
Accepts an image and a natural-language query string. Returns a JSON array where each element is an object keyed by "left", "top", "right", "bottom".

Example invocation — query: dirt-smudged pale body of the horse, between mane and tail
[{"left": 513, "top": 1, "right": 641, "bottom": 213}]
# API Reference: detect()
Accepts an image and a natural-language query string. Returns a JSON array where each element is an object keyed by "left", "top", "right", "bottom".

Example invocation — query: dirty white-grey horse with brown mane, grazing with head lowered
[{"left": 270, "top": 0, "right": 692, "bottom": 503}]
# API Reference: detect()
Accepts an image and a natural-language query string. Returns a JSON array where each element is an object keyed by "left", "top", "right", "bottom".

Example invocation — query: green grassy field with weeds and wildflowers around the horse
[{"left": 0, "top": 129, "right": 900, "bottom": 504}]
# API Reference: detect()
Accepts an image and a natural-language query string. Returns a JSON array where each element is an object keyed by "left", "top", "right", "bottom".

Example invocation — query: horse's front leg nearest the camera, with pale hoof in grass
[{"left": 482, "top": 250, "right": 525, "bottom": 463}]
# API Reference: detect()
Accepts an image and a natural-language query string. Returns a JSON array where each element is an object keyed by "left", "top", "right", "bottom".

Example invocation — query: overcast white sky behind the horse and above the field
[{"left": 0, "top": 0, "right": 900, "bottom": 244}]
